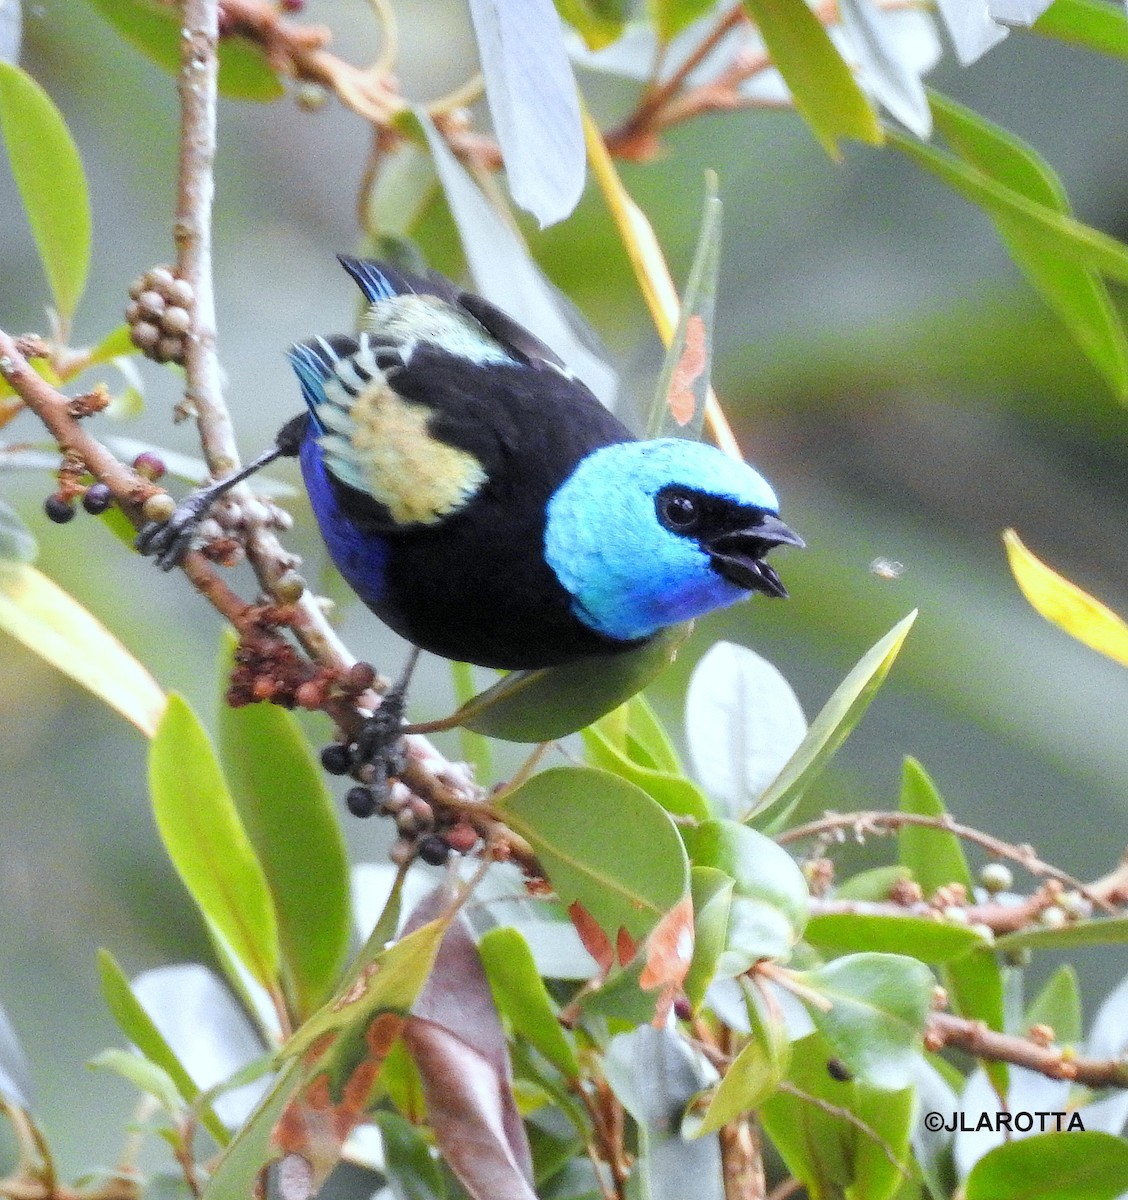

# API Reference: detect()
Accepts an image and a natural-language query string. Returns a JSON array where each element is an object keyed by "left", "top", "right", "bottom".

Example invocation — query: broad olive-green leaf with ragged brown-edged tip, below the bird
[{"left": 497, "top": 767, "right": 689, "bottom": 941}]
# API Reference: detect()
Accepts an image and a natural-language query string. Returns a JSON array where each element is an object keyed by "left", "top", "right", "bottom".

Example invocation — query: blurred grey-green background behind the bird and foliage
[{"left": 0, "top": 0, "right": 1128, "bottom": 1171}]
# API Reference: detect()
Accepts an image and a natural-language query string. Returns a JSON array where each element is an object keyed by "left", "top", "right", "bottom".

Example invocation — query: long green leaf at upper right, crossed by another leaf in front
[{"left": 929, "top": 92, "right": 1128, "bottom": 398}]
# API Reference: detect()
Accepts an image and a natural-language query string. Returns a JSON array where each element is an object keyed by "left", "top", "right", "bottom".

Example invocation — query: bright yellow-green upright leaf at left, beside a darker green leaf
[{"left": 149, "top": 695, "right": 278, "bottom": 992}]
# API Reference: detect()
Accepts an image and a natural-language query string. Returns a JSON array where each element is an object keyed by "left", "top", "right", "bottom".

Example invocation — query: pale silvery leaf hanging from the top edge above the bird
[{"left": 470, "top": 0, "right": 586, "bottom": 228}]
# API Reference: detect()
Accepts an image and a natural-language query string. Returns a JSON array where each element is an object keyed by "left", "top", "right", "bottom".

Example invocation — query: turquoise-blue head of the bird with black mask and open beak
[{"left": 545, "top": 438, "right": 803, "bottom": 641}]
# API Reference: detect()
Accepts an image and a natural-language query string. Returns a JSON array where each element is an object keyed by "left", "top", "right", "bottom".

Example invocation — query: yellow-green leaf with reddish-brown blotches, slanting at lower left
[{"left": 204, "top": 922, "right": 446, "bottom": 1200}]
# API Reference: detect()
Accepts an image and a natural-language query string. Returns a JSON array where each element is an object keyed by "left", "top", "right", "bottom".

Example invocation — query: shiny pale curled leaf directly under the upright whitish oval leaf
[{"left": 685, "top": 821, "right": 808, "bottom": 978}]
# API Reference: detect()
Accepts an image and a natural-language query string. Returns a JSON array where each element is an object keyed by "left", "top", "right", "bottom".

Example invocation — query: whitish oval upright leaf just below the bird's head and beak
[{"left": 685, "top": 642, "right": 806, "bottom": 817}]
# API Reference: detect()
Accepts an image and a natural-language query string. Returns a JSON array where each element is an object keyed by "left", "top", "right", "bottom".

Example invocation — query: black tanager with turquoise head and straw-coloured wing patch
[{"left": 138, "top": 256, "right": 803, "bottom": 670}]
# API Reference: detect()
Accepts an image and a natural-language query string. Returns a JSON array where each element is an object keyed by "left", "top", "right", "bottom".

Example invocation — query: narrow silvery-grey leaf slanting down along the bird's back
[{"left": 415, "top": 109, "right": 616, "bottom": 404}]
